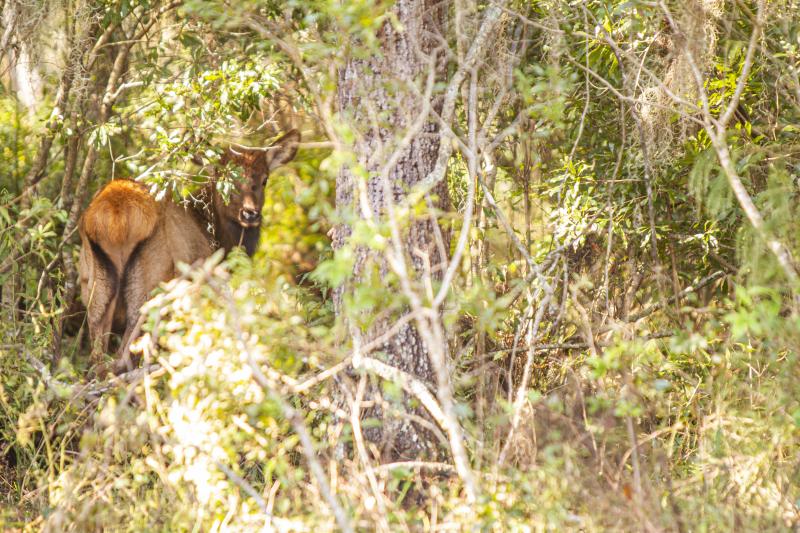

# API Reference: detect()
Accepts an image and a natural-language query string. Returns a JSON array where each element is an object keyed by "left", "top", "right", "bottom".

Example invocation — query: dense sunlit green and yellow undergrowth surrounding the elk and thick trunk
[{"left": 0, "top": 1, "right": 800, "bottom": 532}]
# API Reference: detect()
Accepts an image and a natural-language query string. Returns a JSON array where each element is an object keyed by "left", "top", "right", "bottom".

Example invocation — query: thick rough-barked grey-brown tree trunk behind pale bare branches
[{"left": 333, "top": 0, "right": 448, "bottom": 459}]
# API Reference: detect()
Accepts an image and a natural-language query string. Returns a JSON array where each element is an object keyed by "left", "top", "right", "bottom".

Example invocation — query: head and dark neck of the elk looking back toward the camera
[{"left": 211, "top": 130, "right": 300, "bottom": 255}]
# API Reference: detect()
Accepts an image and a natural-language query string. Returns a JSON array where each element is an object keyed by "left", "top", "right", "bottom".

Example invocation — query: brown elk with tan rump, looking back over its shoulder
[{"left": 78, "top": 130, "right": 300, "bottom": 373}]
